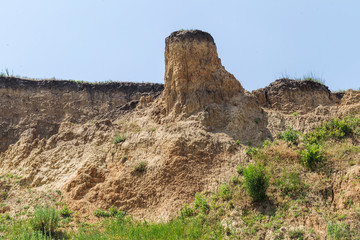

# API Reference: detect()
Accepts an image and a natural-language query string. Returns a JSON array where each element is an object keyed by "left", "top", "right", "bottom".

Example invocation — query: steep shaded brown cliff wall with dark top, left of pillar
[{"left": 0, "top": 77, "right": 163, "bottom": 152}]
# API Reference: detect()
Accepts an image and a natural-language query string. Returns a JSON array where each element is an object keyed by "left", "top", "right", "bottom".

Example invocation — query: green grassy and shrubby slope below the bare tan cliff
[{"left": 0, "top": 116, "right": 360, "bottom": 240}]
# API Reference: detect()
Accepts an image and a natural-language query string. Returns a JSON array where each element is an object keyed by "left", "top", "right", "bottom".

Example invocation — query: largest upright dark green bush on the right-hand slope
[{"left": 243, "top": 164, "right": 269, "bottom": 201}]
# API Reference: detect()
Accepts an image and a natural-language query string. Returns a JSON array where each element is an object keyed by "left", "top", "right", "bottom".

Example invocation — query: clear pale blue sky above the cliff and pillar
[{"left": 0, "top": 0, "right": 360, "bottom": 90}]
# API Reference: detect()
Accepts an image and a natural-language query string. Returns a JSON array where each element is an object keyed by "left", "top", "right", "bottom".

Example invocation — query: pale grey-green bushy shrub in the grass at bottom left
[{"left": 30, "top": 207, "right": 60, "bottom": 235}]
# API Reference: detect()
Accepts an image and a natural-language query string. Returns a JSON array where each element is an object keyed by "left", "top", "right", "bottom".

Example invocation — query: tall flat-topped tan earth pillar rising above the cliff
[{"left": 163, "top": 30, "right": 244, "bottom": 116}]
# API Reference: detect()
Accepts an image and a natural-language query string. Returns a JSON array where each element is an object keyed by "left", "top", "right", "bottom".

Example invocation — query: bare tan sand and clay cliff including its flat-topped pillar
[{"left": 0, "top": 30, "right": 360, "bottom": 238}]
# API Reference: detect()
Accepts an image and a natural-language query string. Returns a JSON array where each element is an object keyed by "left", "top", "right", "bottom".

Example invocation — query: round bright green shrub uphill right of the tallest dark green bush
[{"left": 300, "top": 144, "right": 325, "bottom": 170}]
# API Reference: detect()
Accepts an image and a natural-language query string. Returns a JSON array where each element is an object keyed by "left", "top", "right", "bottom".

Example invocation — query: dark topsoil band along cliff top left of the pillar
[{"left": 0, "top": 77, "right": 164, "bottom": 94}]
